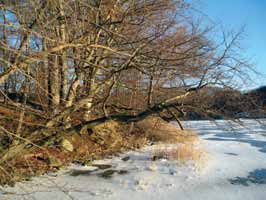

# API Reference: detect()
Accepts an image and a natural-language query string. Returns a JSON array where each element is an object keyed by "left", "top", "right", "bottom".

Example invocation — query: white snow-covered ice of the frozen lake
[{"left": 0, "top": 120, "right": 266, "bottom": 200}]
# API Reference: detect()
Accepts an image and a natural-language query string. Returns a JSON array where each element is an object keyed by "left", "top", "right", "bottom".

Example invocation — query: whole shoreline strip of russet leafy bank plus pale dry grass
[{"left": 0, "top": 116, "right": 203, "bottom": 185}]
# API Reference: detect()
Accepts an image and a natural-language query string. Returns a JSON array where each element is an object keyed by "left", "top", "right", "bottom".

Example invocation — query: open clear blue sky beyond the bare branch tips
[{"left": 193, "top": 0, "right": 266, "bottom": 87}]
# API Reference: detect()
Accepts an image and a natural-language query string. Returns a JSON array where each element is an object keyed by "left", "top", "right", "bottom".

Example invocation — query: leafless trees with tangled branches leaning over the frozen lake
[{"left": 0, "top": 0, "right": 255, "bottom": 155}]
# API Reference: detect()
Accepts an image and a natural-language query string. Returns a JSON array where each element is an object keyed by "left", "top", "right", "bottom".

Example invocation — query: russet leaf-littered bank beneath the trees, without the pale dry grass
[{"left": 0, "top": 118, "right": 148, "bottom": 185}]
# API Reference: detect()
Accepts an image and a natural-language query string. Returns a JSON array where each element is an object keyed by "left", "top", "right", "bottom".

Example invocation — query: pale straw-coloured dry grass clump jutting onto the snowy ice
[{"left": 137, "top": 117, "right": 206, "bottom": 168}]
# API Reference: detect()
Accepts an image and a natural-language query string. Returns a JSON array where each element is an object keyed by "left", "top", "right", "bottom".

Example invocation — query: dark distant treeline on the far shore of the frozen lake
[{"left": 184, "top": 86, "right": 266, "bottom": 120}]
